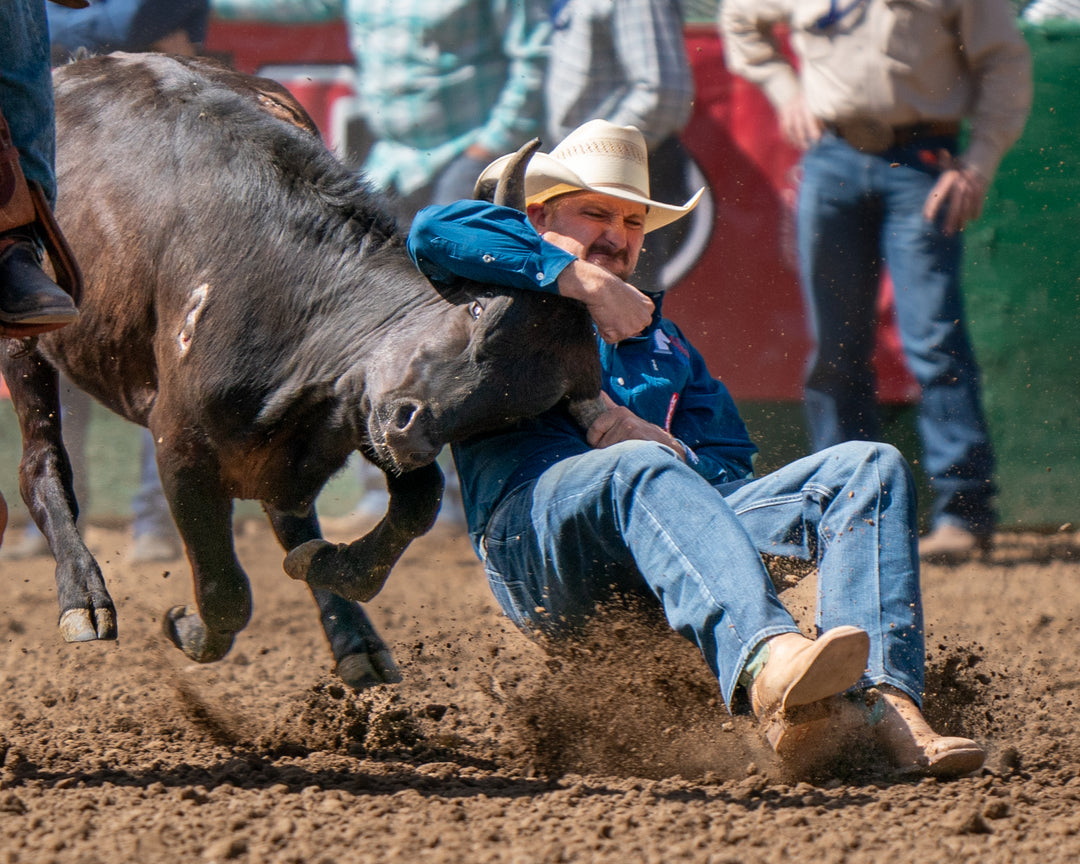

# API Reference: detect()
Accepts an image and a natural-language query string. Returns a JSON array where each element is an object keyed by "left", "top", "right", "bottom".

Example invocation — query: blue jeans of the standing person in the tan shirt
[{"left": 798, "top": 133, "right": 996, "bottom": 534}]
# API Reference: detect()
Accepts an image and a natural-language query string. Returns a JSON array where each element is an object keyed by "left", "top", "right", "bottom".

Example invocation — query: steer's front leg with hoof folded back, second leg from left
[{"left": 151, "top": 427, "right": 252, "bottom": 663}]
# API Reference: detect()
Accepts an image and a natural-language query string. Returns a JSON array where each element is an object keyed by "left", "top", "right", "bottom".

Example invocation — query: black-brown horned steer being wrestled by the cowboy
[{"left": 0, "top": 54, "right": 599, "bottom": 687}]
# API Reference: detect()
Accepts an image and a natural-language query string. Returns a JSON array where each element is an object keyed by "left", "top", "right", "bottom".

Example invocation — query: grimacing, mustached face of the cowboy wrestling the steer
[{"left": 528, "top": 192, "right": 645, "bottom": 281}]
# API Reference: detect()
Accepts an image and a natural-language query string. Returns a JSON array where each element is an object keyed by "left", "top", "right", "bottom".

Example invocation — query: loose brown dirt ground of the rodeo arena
[{"left": 0, "top": 521, "right": 1080, "bottom": 864}]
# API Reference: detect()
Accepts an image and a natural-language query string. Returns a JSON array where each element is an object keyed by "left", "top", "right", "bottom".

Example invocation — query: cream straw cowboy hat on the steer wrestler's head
[{"left": 477, "top": 120, "right": 705, "bottom": 233}]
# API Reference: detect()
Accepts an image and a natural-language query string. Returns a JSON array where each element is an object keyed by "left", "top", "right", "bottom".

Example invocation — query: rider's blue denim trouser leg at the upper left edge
[{"left": 0, "top": 0, "right": 56, "bottom": 204}]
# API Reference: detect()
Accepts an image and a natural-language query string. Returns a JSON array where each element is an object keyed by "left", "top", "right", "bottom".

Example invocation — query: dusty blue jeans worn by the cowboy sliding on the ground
[{"left": 482, "top": 441, "right": 924, "bottom": 705}]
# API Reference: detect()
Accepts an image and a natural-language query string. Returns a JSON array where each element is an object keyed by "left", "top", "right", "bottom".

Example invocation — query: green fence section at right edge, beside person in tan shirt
[{"left": 964, "top": 22, "right": 1080, "bottom": 527}]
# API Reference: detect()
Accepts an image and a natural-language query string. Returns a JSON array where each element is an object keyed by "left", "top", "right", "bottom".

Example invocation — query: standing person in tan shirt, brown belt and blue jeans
[{"left": 720, "top": 0, "right": 1031, "bottom": 559}]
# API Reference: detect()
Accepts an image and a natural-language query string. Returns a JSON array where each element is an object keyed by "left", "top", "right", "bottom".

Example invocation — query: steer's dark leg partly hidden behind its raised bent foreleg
[{"left": 262, "top": 501, "right": 402, "bottom": 690}]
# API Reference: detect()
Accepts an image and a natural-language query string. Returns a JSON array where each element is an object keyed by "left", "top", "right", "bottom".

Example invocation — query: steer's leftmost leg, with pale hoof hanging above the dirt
[{"left": 0, "top": 340, "right": 117, "bottom": 642}]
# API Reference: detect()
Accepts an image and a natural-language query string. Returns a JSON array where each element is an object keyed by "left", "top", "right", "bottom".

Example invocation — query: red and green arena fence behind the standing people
[{"left": 0, "top": 22, "right": 1080, "bottom": 528}]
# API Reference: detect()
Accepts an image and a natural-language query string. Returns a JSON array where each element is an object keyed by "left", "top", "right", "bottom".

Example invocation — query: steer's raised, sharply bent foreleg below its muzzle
[{"left": 285, "top": 463, "right": 443, "bottom": 602}]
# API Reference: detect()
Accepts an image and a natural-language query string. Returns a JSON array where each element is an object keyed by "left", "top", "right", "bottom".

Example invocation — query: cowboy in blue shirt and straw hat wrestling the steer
[{"left": 408, "top": 120, "right": 984, "bottom": 775}]
